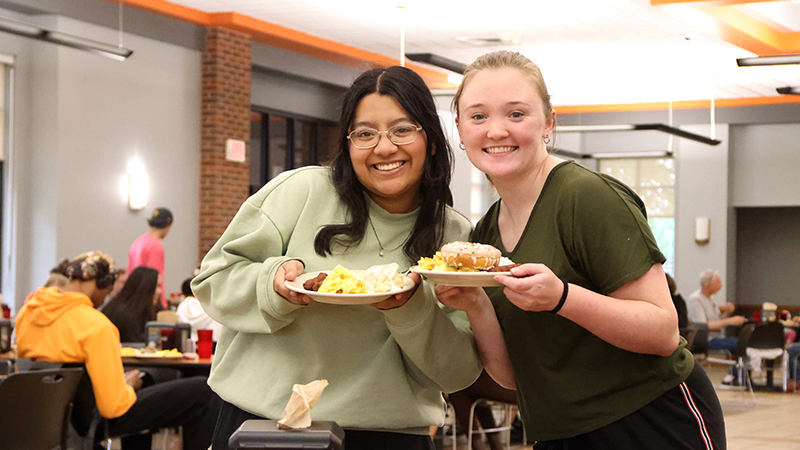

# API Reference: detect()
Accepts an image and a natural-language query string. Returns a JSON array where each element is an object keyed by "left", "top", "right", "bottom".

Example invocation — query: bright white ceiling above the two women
[{"left": 164, "top": 0, "right": 800, "bottom": 105}]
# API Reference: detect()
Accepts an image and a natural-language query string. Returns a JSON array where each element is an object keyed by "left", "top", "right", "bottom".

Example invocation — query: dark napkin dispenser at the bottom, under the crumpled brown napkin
[{"left": 228, "top": 419, "right": 344, "bottom": 450}]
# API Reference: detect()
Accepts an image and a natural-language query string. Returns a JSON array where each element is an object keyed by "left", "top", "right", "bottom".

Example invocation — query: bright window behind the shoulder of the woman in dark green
[{"left": 597, "top": 158, "right": 675, "bottom": 275}]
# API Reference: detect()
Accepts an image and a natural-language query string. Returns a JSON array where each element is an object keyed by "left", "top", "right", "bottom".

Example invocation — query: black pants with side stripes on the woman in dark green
[{"left": 533, "top": 362, "right": 727, "bottom": 450}]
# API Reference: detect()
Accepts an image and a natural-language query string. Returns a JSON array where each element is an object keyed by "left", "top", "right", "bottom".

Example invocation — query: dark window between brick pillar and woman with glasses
[{"left": 250, "top": 111, "right": 337, "bottom": 193}]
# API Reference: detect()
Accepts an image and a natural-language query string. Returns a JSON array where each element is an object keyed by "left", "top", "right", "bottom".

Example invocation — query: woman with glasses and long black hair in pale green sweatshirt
[{"left": 192, "top": 67, "right": 481, "bottom": 450}]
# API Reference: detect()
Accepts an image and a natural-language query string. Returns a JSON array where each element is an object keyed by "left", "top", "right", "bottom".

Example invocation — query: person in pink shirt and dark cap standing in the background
[{"left": 126, "top": 208, "right": 173, "bottom": 309}]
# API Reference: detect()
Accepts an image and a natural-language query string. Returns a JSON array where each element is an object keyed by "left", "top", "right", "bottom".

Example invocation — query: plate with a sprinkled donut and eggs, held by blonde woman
[{"left": 411, "top": 241, "right": 519, "bottom": 287}]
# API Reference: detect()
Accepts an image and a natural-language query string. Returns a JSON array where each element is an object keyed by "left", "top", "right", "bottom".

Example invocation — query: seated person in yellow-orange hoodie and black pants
[{"left": 16, "top": 251, "right": 220, "bottom": 450}]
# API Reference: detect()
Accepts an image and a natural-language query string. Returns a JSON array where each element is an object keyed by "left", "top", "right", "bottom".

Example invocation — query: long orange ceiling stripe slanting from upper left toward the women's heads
[{"left": 107, "top": 0, "right": 456, "bottom": 89}]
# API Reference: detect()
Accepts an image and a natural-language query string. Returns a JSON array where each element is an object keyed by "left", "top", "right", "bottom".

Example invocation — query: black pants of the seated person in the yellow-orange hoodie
[{"left": 108, "top": 377, "right": 222, "bottom": 450}]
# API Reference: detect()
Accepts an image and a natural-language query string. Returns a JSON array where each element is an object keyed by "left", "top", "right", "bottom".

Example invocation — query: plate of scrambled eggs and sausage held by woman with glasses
[{"left": 286, "top": 263, "right": 414, "bottom": 305}]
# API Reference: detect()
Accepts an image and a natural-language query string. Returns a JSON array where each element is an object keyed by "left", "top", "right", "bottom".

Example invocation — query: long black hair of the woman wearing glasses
[{"left": 314, "top": 66, "right": 453, "bottom": 261}]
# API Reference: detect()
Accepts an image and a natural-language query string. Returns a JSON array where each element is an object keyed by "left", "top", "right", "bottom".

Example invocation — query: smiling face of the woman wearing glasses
[{"left": 349, "top": 94, "right": 427, "bottom": 213}]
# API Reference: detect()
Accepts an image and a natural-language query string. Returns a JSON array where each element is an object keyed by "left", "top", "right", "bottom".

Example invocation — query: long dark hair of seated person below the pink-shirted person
[{"left": 102, "top": 266, "right": 158, "bottom": 342}]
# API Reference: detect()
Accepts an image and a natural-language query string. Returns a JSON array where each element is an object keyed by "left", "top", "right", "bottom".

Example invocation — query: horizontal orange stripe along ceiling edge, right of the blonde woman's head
[{"left": 555, "top": 95, "right": 800, "bottom": 114}]
